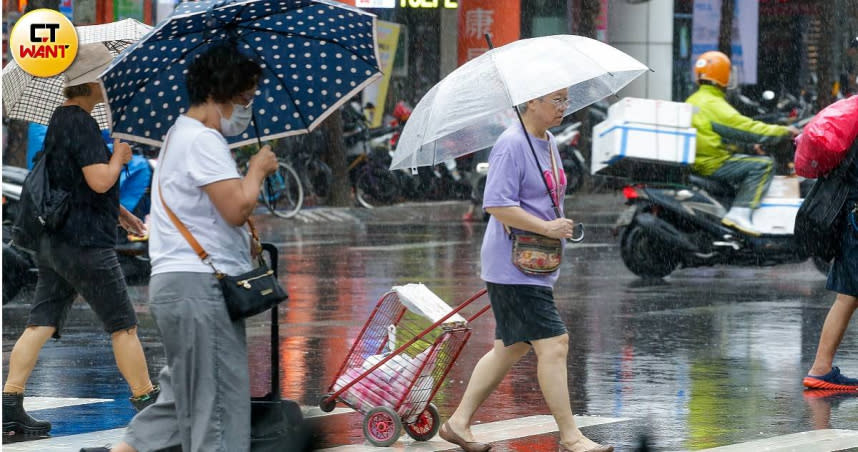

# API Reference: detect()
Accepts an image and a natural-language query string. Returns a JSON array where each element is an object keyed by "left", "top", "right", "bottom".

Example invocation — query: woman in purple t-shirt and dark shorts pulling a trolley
[{"left": 439, "top": 89, "right": 614, "bottom": 452}]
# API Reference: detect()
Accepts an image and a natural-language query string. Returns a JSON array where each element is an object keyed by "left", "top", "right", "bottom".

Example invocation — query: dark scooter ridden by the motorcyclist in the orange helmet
[{"left": 614, "top": 166, "right": 829, "bottom": 278}]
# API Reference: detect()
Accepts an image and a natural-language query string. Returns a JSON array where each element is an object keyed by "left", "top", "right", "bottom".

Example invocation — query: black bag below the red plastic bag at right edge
[{"left": 794, "top": 140, "right": 858, "bottom": 261}]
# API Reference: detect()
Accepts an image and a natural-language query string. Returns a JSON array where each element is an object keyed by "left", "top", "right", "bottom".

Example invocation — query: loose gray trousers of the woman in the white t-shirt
[{"left": 123, "top": 272, "right": 250, "bottom": 452}]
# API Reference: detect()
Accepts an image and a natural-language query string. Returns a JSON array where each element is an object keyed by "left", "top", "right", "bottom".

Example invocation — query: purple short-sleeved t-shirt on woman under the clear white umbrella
[{"left": 480, "top": 124, "right": 566, "bottom": 287}]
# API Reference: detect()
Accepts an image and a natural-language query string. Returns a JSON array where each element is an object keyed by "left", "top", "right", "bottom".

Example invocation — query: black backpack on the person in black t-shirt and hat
[{"left": 12, "top": 151, "right": 70, "bottom": 250}]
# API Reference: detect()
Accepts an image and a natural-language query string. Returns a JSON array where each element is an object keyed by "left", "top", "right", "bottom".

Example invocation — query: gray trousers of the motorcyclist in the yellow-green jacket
[{"left": 709, "top": 154, "right": 774, "bottom": 209}]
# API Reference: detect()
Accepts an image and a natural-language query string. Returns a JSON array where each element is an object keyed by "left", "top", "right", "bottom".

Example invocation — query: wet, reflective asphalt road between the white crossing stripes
[{"left": 3, "top": 195, "right": 858, "bottom": 450}]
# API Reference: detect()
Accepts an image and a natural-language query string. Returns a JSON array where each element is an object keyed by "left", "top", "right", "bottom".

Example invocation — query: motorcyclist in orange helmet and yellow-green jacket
[{"left": 686, "top": 51, "right": 799, "bottom": 235}]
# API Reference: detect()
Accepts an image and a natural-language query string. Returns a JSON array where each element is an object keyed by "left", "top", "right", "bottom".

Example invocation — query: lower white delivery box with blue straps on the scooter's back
[{"left": 590, "top": 119, "right": 697, "bottom": 178}]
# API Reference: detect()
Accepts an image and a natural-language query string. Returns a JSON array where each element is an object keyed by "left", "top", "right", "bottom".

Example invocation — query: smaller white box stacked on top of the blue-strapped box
[{"left": 608, "top": 97, "right": 694, "bottom": 128}]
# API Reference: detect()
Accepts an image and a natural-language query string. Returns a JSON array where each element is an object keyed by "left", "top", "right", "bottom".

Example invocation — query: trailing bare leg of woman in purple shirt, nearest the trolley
[{"left": 447, "top": 340, "right": 530, "bottom": 441}]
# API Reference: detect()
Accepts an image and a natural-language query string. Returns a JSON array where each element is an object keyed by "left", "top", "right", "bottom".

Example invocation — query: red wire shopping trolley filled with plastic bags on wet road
[{"left": 319, "top": 284, "right": 491, "bottom": 447}]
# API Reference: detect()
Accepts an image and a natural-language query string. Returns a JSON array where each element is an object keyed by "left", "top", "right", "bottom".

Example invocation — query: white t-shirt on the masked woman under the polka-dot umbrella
[{"left": 149, "top": 115, "right": 253, "bottom": 275}]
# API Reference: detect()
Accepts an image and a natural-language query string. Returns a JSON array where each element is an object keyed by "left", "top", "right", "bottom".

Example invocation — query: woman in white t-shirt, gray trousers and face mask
[{"left": 99, "top": 45, "right": 277, "bottom": 452}]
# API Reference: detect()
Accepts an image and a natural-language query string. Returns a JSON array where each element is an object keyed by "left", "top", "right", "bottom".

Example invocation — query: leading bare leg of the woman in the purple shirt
[{"left": 533, "top": 334, "right": 598, "bottom": 450}]
